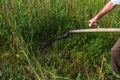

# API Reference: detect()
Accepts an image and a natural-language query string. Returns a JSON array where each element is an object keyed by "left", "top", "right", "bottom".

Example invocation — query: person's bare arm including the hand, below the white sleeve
[{"left": 89, "top": 1, "right": 116, "bottom": 26}]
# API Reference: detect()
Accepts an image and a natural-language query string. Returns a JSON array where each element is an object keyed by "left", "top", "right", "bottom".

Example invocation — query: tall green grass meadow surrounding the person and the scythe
[{"left": 0, "top": 0, "right": 120, "bottom": 80}]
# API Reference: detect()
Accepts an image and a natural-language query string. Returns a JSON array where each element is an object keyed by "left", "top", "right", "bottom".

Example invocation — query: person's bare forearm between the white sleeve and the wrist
[{"left": 94, "top": 1, "right": 115, "bottom": 20}]
